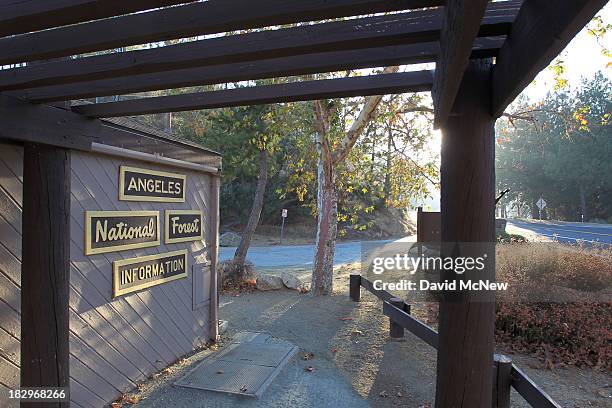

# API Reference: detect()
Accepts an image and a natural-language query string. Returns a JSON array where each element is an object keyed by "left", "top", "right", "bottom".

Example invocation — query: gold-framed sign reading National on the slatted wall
[{"left": 85, "top": 211, "right": 160, "bottom": 255}]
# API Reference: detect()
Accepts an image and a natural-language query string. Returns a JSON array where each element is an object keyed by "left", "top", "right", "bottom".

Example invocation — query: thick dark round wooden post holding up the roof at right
[{"left": 436, "top": 60, "right": 495, "bottom": 408}]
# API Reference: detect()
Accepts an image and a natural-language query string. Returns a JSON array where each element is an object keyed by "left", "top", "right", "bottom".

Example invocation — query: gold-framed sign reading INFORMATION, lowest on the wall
[{"left": 113, "top": 249, "right": 187, "bottom": 298}]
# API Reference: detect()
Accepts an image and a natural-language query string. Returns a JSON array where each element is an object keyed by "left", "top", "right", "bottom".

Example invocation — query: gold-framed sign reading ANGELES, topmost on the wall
[{"left": 119, "top": 166, "right": 187, "bottom": 203}]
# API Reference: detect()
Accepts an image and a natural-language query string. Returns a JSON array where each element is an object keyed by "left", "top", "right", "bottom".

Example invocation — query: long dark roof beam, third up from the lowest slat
[{"left": 0, "top": 2, "right": 518, "bottom": 91}]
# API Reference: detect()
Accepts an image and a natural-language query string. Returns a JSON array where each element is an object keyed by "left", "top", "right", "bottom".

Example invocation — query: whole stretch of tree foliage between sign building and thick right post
[{"left": 163, "top": 76, "right": 438, "bottom": 234}]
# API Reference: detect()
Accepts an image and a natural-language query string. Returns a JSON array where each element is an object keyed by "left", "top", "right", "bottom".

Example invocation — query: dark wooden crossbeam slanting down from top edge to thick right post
[{"left": 432, "top": 0, "right": 488, "bottom": 129}]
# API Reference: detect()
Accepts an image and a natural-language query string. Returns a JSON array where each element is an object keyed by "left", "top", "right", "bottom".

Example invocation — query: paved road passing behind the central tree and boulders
[{"left": 219, "top": 237, "right": 416, "bottom": 268}]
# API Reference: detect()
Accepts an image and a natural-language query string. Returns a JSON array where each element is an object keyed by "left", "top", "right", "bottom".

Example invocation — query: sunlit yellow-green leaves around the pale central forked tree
[{"left": 284, "top": 94, "right": 439, "bottom": 236}]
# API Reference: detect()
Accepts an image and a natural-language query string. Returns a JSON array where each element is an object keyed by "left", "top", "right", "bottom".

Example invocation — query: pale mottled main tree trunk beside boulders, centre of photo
[{"left": 311, "top": 134, "right": 338, "bottom": 296}]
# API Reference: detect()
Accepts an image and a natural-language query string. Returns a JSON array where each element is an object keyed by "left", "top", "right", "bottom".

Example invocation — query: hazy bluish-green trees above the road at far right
[{"left": 496, "top": 74, "right": 612, "bottom": 220}]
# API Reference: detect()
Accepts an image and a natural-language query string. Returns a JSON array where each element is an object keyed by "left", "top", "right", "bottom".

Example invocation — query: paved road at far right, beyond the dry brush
[{"left": 507, "top": 220, "right": 612, "bottom": 245}]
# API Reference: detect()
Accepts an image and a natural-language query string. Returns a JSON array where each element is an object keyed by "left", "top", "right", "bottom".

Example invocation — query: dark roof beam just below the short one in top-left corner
[{"left": 0, "top": 0, "right": 445, "bottom": 65}]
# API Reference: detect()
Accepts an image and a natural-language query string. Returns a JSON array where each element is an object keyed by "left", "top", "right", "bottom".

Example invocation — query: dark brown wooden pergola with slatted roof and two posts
[{"left": 0, "top": 0, "right": 607, "bottom": 408}]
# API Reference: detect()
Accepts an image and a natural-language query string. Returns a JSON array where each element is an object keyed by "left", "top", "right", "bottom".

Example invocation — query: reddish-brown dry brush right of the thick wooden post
[{"left": 496, "top": 243, "right": 612, "bottom": 370}]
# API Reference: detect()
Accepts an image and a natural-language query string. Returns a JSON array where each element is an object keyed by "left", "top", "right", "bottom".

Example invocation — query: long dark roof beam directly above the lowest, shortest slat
[{"left": 20, "top": 37, "right": 504, "bottom": 102}]
